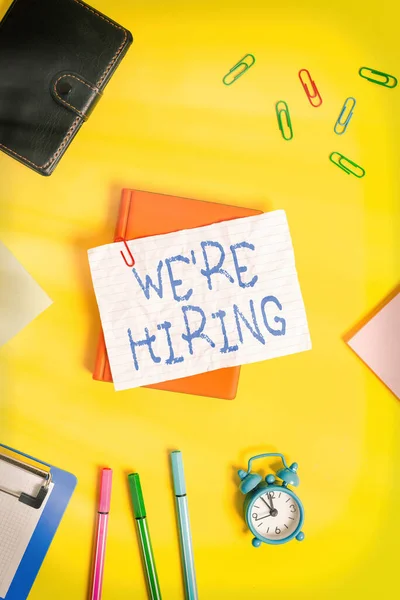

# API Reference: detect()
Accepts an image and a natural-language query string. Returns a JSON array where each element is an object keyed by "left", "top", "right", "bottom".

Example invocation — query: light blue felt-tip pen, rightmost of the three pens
[{"left": 171, "top": 450, "right": 198, "bottom": 600}]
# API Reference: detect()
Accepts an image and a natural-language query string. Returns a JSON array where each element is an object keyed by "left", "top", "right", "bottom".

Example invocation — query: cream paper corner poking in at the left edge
[{"left": 0, "top": 242, "right": 52, "bottom": 346}]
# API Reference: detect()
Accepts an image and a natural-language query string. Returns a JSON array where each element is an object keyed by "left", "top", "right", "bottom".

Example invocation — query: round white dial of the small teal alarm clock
[{"left": 248, "top": 487, "right": 302, "bottom": 543}]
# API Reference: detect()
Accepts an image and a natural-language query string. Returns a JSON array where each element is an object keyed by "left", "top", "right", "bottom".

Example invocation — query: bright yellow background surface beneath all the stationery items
[{"left": 0, "top": 0, "right": 400, "bottom": 600}]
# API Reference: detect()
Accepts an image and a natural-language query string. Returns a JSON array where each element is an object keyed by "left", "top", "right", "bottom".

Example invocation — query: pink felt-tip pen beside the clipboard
[{"left": 90, "top": 469, "right": 112, "bottom": 600}]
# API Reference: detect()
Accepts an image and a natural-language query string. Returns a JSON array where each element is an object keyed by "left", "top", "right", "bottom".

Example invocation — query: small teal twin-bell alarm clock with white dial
[{"left": 238, "top": 452, "right": 304, "bottom": 548}]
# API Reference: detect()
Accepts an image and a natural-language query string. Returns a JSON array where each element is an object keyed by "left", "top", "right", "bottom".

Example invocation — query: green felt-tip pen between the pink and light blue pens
[{"left": 128, "top": 473, "right": 161, "bottom": 600}]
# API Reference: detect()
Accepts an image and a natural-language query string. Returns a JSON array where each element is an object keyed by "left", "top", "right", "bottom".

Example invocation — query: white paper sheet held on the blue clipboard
[{"left": 0, "top": 460, "right": 54, "bottom": 598}]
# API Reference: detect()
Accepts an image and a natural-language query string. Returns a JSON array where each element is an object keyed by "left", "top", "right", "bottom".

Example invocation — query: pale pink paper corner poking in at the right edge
[{"left": 347, "top": 293, "right": 400, "bottom": 398}]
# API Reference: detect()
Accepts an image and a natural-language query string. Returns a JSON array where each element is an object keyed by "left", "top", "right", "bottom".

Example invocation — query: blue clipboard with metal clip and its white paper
[{"left": 0, "top": 444, "right": 76, "bottom": 600}]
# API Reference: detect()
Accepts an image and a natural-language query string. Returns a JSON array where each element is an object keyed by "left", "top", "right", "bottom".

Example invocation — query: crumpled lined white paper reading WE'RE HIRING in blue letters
[{"left": 88, "top": 210, "right": 311, "bottom": 390}]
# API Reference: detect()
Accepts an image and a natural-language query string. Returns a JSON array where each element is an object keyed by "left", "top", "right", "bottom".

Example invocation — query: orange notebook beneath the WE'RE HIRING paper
[{"left": 93, "top": 189, "right": 262, "bottom": 400}]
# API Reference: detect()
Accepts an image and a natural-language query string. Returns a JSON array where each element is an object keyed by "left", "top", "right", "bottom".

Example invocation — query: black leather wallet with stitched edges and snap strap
[{"left": 0, "top": 0, "right": 132, "bottom": 175}]
